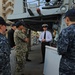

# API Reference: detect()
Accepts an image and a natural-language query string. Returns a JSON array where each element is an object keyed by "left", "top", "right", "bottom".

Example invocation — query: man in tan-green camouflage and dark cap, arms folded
[{"left": 14, "top": 21, "right": 29, "bottom": 75}]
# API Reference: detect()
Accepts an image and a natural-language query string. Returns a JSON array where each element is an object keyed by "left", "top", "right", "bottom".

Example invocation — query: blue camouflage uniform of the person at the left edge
[{"left": 0, "top": 33, "right": 11, "bottom": 75}]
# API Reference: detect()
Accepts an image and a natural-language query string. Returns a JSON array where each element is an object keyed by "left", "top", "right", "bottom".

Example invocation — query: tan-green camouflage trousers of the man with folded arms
[{"left": 15, "top": 50, "right": 26, "bottom": 75}]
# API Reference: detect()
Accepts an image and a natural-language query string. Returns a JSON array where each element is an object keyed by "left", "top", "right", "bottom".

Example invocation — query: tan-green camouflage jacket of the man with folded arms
[{"left": 14, "top": 29, "right": 28, "bottom": 52}]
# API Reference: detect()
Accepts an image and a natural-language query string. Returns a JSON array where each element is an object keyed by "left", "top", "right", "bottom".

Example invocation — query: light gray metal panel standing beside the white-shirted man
[{"left": 44, "top": 46, "right": 61, "bottom": 75}]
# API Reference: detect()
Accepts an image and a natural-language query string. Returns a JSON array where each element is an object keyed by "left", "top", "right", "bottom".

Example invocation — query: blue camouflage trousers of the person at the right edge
[{"left": 59, "top": 58, "right": 75, "bottom": 75}]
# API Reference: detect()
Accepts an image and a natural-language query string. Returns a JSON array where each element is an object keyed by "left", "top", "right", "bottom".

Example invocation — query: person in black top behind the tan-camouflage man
[{"left": 8, "top": 23, "right": 16, "bottom": 49}]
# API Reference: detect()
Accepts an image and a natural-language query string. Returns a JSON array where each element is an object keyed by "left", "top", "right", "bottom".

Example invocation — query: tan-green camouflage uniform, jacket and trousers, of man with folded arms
[{"left": 14, "top": 29, "right": 27, "bottom": 75}]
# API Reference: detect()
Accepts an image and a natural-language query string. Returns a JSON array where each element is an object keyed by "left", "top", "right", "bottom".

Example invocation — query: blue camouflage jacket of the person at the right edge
[{"left": 58, "top": 24, "right": 75, "bottom": 61}]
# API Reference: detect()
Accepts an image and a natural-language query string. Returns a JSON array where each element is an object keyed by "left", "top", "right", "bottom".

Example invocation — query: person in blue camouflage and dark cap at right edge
[{"left": 57, "top": 9, "right": 75, "bottom": 75}]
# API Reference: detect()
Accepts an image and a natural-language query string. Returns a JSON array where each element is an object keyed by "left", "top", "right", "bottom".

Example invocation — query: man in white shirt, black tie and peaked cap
[{"left": 39, "top": 24, "right": 52, "bottom": 63}]
